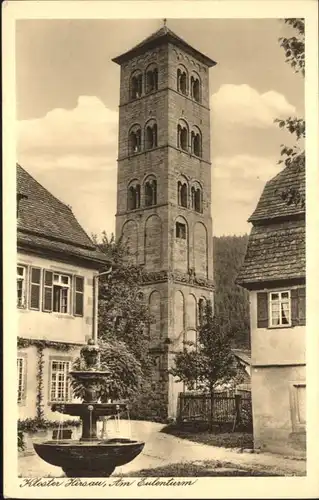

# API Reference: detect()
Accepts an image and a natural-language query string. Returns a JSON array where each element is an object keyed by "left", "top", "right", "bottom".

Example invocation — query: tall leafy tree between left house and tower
[{"left": 93, "top": 232, "right": 152, "bottom": 377}]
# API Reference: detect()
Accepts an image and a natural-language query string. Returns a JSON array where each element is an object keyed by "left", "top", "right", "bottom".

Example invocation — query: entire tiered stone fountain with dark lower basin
[{"left": 33, "top": 340, "right": 145, "bottom": 477}]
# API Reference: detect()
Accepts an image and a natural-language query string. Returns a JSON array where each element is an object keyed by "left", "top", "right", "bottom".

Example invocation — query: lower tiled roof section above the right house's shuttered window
[{"left": 236, "top": 219, "right": 306, "bottom": 286}]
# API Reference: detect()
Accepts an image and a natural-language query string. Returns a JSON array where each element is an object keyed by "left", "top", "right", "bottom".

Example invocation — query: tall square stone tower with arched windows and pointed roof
[{"left": 113, "top": 26, "right": 216, "bottom": 417}]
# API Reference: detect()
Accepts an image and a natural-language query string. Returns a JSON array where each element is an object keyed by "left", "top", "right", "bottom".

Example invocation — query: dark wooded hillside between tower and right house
[{"left": 213, "top": 235, "right": 250, "bottom": 348}]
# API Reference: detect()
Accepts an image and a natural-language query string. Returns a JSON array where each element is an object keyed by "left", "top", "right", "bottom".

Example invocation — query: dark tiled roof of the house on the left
[{"left": 17, "top": 165, "right": 107, "bottom": 261}]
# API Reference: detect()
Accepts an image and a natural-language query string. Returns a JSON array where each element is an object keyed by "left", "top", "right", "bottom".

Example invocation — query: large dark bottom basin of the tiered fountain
[{"left": 33, "top": 438, "right": 145, "bottom": 477}]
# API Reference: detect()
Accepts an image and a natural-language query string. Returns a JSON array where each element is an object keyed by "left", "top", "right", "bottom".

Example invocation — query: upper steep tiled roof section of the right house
[{"left": 248, "top": 162, "right": 306, "bottom": 223}]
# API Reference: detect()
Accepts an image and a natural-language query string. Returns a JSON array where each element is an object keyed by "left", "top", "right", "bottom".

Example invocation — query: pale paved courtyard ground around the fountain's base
[{"left": 18, "top": 421, "right": 306, "bottom": 477}]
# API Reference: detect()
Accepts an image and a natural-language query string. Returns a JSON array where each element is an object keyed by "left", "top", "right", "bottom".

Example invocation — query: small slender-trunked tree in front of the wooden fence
[{"left": 170, "top": 301, "right": 236, "bottom": 428}]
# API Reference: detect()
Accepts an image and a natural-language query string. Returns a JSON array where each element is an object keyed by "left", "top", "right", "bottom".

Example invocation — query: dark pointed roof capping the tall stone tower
[{"left": 112, "top": 25, "right": 217, "bottom": 68}]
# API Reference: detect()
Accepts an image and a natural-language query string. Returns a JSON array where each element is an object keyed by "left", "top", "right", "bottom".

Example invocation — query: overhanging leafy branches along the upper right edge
[{"left": 275, "top": 18, "right": 306, "bottom": 208}]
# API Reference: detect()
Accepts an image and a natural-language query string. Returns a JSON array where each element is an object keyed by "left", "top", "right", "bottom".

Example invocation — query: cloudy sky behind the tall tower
[{"left": 15, "top": 19, "right": 304, "bottom": 236}]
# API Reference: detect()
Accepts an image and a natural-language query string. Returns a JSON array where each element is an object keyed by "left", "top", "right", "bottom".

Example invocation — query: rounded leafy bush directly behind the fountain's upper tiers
[{"left": 71, "top": 340, "right": 143, "bottom": 402}]
